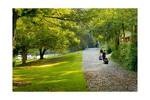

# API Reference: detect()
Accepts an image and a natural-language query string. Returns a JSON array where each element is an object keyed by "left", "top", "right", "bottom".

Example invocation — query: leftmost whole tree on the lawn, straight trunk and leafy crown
[{"left": 15, "top": 17, "right": 35, "bottom": 64}]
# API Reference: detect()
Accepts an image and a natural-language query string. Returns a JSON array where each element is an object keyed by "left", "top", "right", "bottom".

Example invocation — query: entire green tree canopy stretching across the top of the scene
[{"left": 13, "top": 8, "right": 137, "bottom": 66}]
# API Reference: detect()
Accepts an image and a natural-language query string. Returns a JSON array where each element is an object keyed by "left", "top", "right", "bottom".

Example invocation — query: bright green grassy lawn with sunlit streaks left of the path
[{"left": 13, "top": 52, "right": 87, "bottom": 91}]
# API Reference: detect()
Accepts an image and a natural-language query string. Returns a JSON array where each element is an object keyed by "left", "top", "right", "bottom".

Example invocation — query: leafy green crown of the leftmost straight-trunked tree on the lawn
[{"left": 15, "top": 17, "right": 34, "bottom": 48}]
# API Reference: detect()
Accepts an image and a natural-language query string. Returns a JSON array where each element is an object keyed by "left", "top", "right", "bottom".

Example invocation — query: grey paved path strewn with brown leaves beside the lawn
[{"left": 83, "top": 48, "right": 137, "bottom": 91}]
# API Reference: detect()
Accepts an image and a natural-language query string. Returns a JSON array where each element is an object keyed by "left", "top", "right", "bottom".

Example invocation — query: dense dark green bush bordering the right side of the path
[{"left": 111, "top": 43, "right": 137, "bottom": 71}]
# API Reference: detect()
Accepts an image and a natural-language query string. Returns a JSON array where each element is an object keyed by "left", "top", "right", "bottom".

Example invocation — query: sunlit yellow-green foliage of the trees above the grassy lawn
[{"left": 13, "top": 9, "right": 80, "bottom": 62}]
